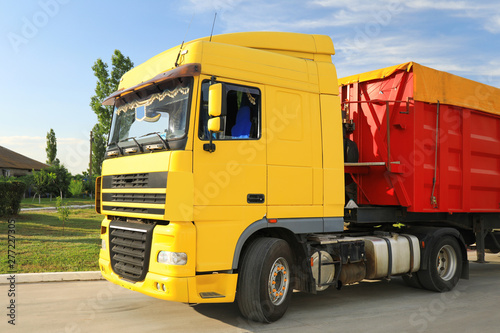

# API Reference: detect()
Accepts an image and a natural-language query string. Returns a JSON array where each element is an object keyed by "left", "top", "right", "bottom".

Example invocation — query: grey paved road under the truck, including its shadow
[{"left": 0, "top": 255, "right": 500, "bottom": 333}]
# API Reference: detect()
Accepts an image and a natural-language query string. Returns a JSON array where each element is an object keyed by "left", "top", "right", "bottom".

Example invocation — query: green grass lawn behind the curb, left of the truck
[{"left": 0, "top": 209, "right": 102, "bottom": 274}]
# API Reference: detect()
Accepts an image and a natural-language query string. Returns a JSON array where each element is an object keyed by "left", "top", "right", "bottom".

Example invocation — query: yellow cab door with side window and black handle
[{"left": 193, "top": 77, "right": 267, "bottom": 271}]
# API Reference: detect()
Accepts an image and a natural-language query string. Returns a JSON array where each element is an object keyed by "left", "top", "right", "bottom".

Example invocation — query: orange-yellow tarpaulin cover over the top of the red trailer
[{"left": 339, "top": 62, "right": 500, "bottom": 115}]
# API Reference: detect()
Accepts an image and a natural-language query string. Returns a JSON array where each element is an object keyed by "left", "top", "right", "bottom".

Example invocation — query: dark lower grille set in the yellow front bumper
[{"left": 109, "top": 220, "right": 154, "bottom": 281}]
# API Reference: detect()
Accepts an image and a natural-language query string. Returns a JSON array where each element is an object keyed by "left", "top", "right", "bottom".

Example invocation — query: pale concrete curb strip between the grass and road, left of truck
[{"left": 0, "top": 271, "right": 104, "bottom": 285}]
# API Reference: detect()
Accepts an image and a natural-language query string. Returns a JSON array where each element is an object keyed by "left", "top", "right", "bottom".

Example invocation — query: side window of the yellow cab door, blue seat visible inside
[{"left": 198, "top": 80, "right": 261, "bottom": 140}]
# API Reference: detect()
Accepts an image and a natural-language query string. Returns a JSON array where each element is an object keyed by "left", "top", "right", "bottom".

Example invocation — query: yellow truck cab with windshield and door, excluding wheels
[{"left": 96, "top": 33, "right": 344, "bottom": 320}]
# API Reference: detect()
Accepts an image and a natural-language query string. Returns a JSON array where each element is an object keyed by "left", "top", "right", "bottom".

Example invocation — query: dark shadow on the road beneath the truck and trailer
[{"left": 193, "top": 262, "right": 500, "bottom": 332}]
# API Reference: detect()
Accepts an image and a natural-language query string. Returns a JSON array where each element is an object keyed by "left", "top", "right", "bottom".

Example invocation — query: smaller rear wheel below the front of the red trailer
[{"left": 417, "top": 236, "right": 462, "bottom": 292}]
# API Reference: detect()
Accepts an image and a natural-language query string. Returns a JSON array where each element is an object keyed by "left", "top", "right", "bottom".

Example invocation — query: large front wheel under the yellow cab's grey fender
[{"left": 236, "top": 238, "right": 292, "bottom": 323}]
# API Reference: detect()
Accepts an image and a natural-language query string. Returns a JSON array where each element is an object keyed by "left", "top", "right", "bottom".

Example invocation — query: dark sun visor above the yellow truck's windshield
[{"left": 102, "top": 64, "right": 201, "bottom": 105}]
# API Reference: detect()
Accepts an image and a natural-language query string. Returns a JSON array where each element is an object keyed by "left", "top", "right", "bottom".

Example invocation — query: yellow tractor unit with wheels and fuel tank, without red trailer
[{"left": 96, "top": 32, "right": 500, "bottom": 322}]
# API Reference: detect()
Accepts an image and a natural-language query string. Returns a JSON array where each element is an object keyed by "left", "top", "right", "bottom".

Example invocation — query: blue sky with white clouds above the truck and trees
[{"left": 0, "top": 0, "right": 500, "bottom": 174}]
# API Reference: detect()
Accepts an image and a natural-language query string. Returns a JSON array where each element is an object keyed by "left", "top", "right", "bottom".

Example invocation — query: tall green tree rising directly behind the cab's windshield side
[{"left": 90, "top": 50, "right": 134, "bottom": 175}]
